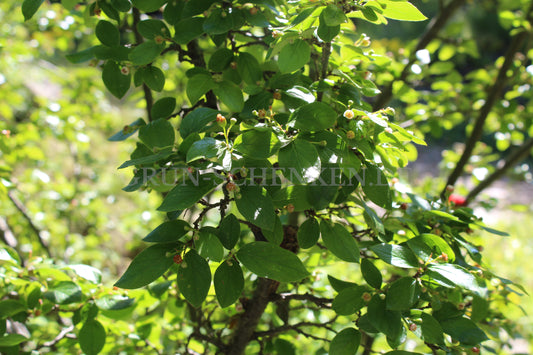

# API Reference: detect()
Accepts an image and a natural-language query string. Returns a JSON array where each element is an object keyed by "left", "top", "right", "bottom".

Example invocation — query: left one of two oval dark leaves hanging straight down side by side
[{"left": 178, "top": 250, "right": 211, "bottom": 307}]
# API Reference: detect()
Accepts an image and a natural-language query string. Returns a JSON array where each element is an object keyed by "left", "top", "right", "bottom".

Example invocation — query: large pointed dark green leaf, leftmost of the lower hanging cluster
[{"left": 114, "top": 244, "right": 174, "bottom": 289}]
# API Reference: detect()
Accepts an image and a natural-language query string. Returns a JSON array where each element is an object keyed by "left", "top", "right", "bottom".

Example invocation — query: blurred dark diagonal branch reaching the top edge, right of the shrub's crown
[{"left": 372, "top": 0, "right": 465, "bottom": 111}]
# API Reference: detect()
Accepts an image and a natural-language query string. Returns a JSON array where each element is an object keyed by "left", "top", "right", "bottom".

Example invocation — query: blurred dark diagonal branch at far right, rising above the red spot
[{"left": 441, "top": 31, "right": 529, "bottom": 196}]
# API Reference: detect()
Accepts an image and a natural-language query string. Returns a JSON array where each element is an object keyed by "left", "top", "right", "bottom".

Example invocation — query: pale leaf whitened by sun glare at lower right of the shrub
[{"left": 425, "top": 264, "right": 487, "bottom": 297}]
